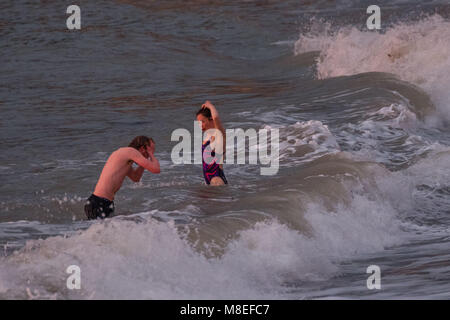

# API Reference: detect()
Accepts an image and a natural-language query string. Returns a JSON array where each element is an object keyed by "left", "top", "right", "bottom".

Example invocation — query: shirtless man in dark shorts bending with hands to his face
[{"left": 84, "top": 136, "right": 160, "bottom": 219}]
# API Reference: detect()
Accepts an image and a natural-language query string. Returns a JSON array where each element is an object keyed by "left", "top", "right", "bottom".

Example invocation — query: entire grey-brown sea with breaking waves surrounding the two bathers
[{"left": 0, "top": 1, "right": 450, "bottom": 299}]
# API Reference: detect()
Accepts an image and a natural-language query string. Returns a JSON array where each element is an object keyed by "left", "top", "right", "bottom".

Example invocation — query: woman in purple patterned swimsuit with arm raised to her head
[{"left": 196, "top": 101, "right": 228, "bottom": 186}]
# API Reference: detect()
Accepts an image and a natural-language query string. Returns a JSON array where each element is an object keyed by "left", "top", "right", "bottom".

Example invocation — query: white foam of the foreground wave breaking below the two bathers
[{"left": 0, "top": 161, "right": 408, "bottom": 299}]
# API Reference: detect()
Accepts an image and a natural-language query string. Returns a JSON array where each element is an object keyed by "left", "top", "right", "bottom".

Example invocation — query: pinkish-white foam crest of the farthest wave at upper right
[{"left": 295, "top": 15, "right": 450, "bottom": 124}]
